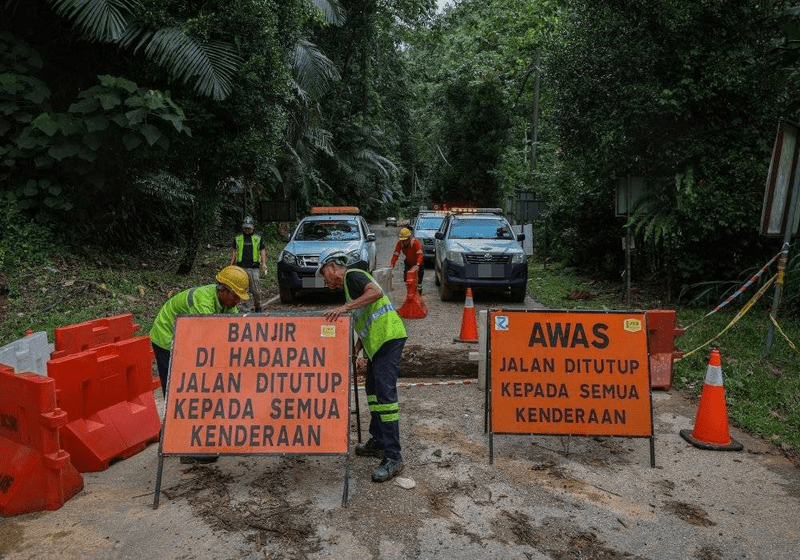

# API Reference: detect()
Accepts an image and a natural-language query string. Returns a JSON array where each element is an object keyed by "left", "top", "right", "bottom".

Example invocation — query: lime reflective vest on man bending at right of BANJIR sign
[{"left": 344, "top": 269, "right": 408, "bottom": 359}]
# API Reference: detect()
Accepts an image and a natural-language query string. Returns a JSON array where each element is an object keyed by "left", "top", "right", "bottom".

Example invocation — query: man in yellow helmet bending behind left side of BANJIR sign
[{"left": 150, "top": 266, "right": 249, "bottom": 464}]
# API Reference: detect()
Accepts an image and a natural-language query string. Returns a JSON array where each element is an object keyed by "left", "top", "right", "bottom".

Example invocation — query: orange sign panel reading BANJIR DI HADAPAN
[{"left": 161, "top": 315, "right": 351, "bottom": 454}]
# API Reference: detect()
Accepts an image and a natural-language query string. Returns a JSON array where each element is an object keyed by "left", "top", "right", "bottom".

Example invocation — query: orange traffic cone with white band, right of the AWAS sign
[{"left": 680, "top": 348, "right": 743, "bottom": 451}]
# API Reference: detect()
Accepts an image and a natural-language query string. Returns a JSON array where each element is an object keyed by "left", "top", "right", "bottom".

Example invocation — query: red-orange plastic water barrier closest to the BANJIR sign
[{"left": 47, "top": 336, "right": 161, "bottom": 472}]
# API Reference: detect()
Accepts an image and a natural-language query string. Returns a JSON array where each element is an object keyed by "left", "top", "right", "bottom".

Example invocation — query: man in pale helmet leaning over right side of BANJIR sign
[{"left": 317, "top": 249, "right": 407, "bottom": 482}]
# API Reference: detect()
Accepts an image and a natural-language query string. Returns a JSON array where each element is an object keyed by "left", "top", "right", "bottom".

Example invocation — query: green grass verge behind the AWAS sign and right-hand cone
[{"left": 528, "top": 264, "right": 800, "bottom": 460}]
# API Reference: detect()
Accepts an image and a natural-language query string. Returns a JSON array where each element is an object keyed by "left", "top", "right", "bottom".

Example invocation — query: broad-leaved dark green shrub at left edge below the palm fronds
[{"left": 0, "top": 33, "right": 190, "bottom": 226}]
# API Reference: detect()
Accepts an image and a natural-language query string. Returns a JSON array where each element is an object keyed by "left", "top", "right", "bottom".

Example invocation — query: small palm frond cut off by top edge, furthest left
[{"left": 47, "top": 0, "right": 138, "bottom": 41}]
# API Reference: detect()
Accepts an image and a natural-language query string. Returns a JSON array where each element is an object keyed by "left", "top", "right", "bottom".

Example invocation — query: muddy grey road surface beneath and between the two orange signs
[{"left": 0, "top": 226, "right": 800, "bottom": 560}]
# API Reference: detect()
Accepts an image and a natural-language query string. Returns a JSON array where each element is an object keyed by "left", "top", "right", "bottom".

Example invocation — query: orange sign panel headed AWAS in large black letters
[{"left": 488, "top": 310, "right": 653, "bottom": 437}]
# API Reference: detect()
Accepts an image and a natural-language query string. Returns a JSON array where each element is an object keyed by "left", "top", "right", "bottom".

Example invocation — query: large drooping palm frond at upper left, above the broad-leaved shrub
[{"left": 119, "top": 27, "right": 241, "bottom": 101}]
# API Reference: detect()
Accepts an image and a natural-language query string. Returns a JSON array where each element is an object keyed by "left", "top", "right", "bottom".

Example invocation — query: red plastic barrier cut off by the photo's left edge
[{"left": 0, "top": 366, "right": 83, "bottom": 517}]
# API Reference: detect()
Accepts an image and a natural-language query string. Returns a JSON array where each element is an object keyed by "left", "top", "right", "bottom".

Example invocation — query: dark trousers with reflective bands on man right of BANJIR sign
[{"left": 364, "top": 338, "right": 406, "bottom": 461}]
